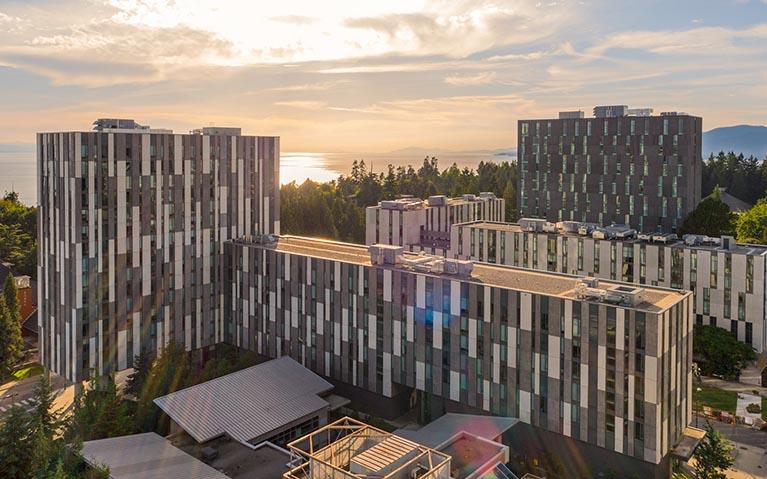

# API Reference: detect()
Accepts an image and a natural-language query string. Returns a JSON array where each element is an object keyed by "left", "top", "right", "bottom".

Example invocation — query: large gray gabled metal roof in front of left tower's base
[{"left": 154, "top": 356, "right": 333, "bottom": 442}]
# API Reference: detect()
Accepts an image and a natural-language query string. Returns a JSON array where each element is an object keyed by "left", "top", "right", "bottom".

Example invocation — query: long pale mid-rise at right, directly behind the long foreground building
[{"left": 450, "top": 219, "right": 767, "bottom": 353}]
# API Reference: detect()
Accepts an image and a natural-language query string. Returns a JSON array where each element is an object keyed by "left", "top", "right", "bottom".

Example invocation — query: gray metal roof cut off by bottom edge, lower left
[{"left": 82, "top": 432, "right": 227, "bottom": 479}]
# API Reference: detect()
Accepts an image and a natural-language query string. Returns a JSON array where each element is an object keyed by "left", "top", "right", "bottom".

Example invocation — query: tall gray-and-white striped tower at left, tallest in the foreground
[{"left": 37, "top": 119, "right": 280, "bottom": 381}]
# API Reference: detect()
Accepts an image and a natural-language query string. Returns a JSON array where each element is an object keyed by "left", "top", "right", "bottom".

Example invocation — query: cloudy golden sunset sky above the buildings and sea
[{"left": 0, "top": 0, "right": 767, "bottom": 153}]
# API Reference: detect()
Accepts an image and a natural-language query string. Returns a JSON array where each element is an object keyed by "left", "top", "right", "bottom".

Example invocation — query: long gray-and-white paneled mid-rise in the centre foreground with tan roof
[{"left": 225, "top": 236, "right": 693, "bottom": 477}]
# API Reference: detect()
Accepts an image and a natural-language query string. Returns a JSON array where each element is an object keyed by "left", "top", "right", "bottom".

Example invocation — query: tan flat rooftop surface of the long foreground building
[{"left": 233, "top": 235, "right": 692, "bottom": 313}]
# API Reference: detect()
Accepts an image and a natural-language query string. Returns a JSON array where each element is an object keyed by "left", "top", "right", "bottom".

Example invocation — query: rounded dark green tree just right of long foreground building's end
[{"left": 693, "top": 325, "right": 756, "bottom": 379}]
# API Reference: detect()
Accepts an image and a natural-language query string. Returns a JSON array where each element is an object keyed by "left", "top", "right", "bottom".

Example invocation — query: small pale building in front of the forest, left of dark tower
[{"left": 365, "top": 193, "right": 506, "bottom": 254}]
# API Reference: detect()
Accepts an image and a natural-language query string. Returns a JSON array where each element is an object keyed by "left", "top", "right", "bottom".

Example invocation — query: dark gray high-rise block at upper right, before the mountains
[{"left": 517, "top": 105, "right": 703, "bottom": 232}]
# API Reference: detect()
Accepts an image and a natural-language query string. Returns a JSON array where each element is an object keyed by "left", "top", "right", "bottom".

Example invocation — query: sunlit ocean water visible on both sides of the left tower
[{"left": 0, "top": 149, "right": 510, "bottom": 205}]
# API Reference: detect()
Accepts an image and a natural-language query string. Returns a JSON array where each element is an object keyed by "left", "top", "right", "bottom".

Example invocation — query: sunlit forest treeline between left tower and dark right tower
[{"left": 280, "top": 157, "right": 517, "bottom": 243}]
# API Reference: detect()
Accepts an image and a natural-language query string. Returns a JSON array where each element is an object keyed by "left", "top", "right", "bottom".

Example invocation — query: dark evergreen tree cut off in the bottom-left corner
[{"left": 0, "top": 404, "right": 34, "bottom": 479}]
